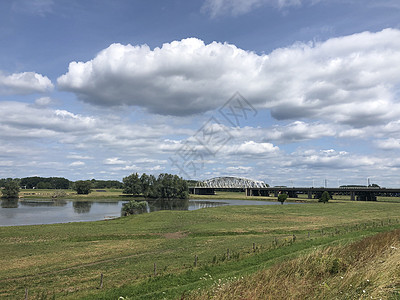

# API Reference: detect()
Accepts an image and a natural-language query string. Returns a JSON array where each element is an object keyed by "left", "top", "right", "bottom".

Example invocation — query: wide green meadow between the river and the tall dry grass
[{"left": 0, "top": 202, "right": 400, "bottom": 299}]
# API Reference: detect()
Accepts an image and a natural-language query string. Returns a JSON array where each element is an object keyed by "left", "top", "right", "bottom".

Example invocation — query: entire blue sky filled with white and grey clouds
[{"left": 0, "top": 0, "right": 400, "bottom": 187}]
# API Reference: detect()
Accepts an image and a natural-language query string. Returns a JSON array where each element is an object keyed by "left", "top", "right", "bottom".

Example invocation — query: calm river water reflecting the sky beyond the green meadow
[{"left": 0, "top": 199, "right": 296, "bottom": 226}]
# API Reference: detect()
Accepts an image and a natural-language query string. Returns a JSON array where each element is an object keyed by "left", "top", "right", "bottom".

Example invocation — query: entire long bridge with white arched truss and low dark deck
[{"left": 189, "top": 177, "right": 400, "bottom": 201}]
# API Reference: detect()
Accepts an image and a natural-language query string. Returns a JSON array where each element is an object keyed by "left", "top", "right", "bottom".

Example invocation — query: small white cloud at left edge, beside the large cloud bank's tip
[{"left": 0, "top": 71, "right": 54, "bottom": 95}]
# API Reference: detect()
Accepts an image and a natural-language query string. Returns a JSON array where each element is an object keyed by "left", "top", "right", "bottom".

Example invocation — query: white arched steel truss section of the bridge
[{"left": 196, "top": 177, "right": 268, "bottom": 189}]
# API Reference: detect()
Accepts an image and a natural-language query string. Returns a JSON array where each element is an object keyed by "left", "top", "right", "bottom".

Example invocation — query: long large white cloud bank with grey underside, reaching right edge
[{"left": 58, "top": 29, "right": 400, "bottom": 128}]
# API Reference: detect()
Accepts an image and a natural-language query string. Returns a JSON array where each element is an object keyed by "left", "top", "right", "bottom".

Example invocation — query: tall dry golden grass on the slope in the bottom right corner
[{"left": 190, "top": 230, "right": 400, "bottom": 300}]
